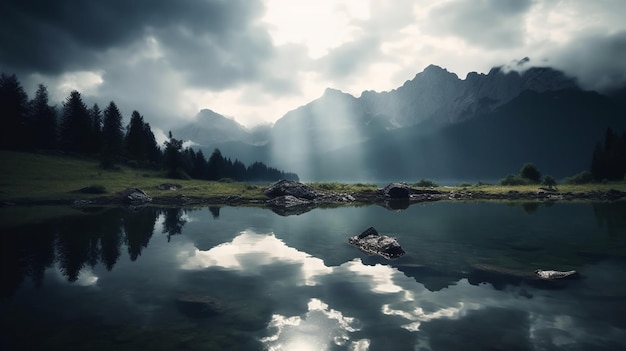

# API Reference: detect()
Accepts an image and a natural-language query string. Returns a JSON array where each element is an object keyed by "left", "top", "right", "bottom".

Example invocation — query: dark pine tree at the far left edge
[{"left": 0, "top": 73, "right": 28, "bottom": 150}]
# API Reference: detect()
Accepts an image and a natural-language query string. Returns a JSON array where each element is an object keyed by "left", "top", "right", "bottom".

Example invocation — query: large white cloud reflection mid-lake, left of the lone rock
[{"left": 179, "top": 230, "right": 332, "bottom": 285}]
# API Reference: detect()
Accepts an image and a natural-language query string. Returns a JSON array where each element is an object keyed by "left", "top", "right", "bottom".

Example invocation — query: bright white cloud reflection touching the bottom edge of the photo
[{"left": 261, "top": 299, "right": 369, "bottom": 351}]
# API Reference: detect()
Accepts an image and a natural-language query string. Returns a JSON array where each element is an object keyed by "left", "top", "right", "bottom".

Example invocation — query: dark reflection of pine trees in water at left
[{"left": 0, "top": 208, "right": 161, "bottom": 296}]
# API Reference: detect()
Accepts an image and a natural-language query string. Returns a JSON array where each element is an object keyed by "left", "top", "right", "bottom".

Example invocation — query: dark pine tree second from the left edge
[{"left": 30, "top": 84, "right": 57, "bottom": 149}]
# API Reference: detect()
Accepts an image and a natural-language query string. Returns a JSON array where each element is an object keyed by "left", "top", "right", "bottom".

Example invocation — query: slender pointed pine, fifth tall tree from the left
[{"left": 100, "top": 101, "right": 124, "bottom": 168}]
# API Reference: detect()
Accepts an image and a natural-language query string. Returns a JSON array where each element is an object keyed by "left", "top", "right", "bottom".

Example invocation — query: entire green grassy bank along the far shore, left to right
[{"left": 0, "top": 150, "right": 626, "bottom": 202}]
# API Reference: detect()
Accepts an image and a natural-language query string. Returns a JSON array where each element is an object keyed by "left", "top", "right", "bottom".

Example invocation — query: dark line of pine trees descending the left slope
[{"left": 0, "top": 73, "right": 298, "bottom": 181}]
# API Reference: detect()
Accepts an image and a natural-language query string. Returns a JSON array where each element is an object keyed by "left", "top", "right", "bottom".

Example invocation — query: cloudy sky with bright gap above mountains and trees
[{"left": 0, "top": 0, "right": 626, "bottom": 130}]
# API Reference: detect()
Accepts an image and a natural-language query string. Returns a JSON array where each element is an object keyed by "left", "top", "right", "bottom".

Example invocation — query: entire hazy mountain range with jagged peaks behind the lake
[{"left": 173, "top": 65, "right": 626, "bottom": 181}]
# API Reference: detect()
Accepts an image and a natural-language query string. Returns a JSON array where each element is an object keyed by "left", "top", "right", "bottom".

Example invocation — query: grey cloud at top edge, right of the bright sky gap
[{"left": 423, "top": 0, "right": 532, "bottom": 48}]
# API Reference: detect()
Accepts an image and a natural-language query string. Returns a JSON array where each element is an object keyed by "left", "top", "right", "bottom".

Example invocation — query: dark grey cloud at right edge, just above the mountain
[{"left": 547, "top": 31, "right": 626, "bottom": 91}]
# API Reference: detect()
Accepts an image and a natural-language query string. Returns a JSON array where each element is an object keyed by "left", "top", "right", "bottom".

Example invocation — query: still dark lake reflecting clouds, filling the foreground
[{"left": 0, "top": 202, "right": 626, "bottom": 351}]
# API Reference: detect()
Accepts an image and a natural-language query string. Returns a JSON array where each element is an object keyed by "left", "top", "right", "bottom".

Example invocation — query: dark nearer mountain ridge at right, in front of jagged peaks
[{"left": 301, "top": 89, "right": 626, "bottom": 181}]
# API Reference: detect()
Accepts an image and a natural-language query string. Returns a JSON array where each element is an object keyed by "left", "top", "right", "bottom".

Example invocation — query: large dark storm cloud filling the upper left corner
[{"left": 0, "top": 0, "right": 271, "bottom": 88}]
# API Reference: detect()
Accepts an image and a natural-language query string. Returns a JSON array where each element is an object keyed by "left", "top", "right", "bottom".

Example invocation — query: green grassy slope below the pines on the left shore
[{"left": 0, "top": 150, "right": 264, "bottom": 201}]
